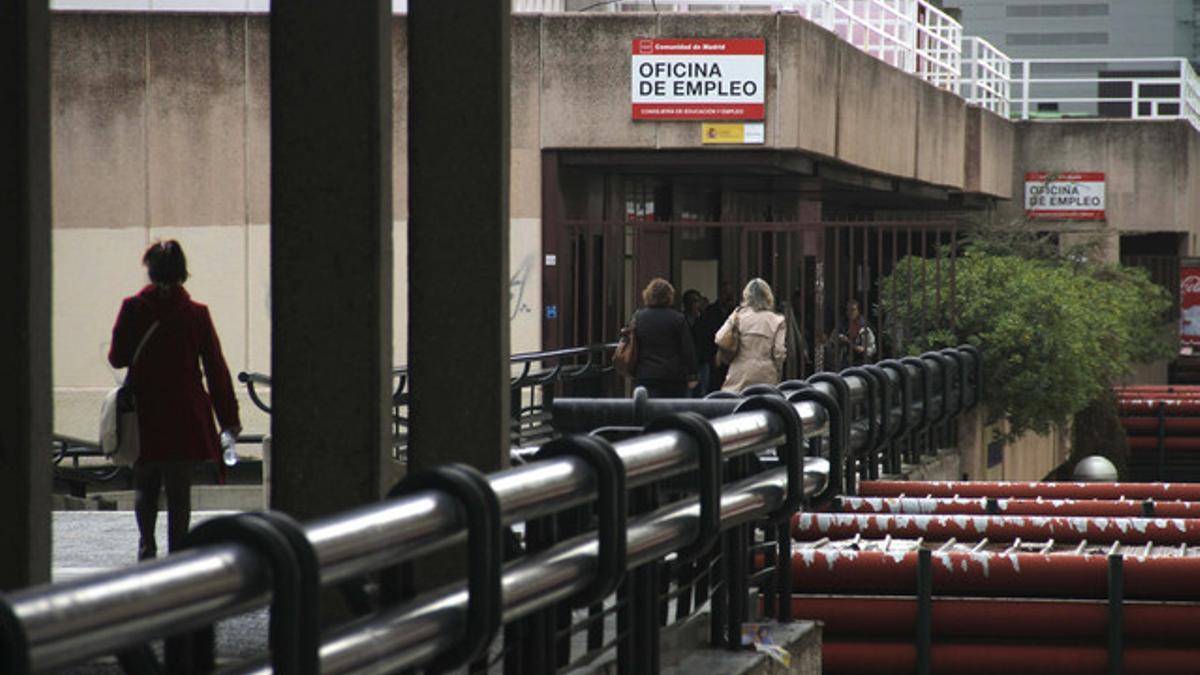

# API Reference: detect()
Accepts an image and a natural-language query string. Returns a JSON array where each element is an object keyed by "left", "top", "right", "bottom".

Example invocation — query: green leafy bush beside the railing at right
[{"left": 882, "top": 231, "right": 1171, "bottom": 436}]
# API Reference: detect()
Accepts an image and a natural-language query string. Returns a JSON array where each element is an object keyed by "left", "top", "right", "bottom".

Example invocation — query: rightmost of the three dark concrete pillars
[{"left": 408, "top": 0, "right": 510, "bottom": 471}]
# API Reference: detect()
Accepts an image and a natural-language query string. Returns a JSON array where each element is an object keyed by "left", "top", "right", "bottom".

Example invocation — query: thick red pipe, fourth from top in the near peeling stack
[{"left": 792, "top": 548, "right": 1200, "bottom": 601}]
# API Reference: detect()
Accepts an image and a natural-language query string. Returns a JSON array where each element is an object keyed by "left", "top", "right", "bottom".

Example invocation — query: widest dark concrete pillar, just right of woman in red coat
[{"left": 271, "top": 0, "right": 392, "bottom": 519}]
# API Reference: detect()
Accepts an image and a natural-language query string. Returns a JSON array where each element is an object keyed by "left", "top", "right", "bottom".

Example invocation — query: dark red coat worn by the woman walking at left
[{"left": 108, "top": 285, "right": 241, "bottom": 461}]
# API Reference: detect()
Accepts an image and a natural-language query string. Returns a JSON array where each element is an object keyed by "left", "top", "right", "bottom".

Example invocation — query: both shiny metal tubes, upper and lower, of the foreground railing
[{"left": 0, "top": 343, "right": 979, "bottom": 673}]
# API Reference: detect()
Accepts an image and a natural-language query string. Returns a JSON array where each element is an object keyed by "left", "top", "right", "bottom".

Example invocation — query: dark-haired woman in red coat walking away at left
[{"left": 108, "top": 240, "right": 241, "bottom": 560}]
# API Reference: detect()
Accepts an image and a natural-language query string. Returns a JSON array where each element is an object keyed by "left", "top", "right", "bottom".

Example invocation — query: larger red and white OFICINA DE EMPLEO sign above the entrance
[{"left": 630, "top": 37, "right": 767, "bottom": 120}]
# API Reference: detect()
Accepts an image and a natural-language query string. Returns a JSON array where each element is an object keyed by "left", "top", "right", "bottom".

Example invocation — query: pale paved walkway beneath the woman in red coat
[{"left": 52, "top": 510, "right": 268, "bottom": 675}]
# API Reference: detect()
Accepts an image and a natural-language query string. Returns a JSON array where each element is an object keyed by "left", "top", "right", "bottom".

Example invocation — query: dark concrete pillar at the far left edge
[{"left": 0, "top": 1, "right": 52, "bottom": 590}]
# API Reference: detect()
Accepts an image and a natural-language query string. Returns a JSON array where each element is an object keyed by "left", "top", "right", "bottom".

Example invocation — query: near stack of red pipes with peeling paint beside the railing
[{"left": 792, "top": 480, "right": 1200, "bottom": 675}]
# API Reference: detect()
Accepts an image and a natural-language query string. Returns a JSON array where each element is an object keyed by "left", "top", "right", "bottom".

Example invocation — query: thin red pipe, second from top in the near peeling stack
[{"left": 839, "top": 497, "right": 1200, "bottom": 518}]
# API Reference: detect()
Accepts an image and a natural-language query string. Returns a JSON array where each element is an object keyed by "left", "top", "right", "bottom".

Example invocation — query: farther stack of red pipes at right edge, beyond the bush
[{"left": 1114, "top": 384, "right": 1200, "bottom": 483}]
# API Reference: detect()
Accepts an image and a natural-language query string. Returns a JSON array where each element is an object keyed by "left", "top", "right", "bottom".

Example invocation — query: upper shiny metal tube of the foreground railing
[{"left": 7, "top": 396, "right": 823, "bottom": 671}]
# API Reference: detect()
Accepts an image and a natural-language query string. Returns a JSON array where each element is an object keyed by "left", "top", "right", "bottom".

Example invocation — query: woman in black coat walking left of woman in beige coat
[{"left": 631, "top": 277, "right": 698, "bottom": 399}]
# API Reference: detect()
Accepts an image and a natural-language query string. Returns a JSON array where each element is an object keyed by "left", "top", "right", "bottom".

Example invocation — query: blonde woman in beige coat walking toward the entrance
[{"left": 714, "top": 279, "right": 787, "bottom": 392}]
